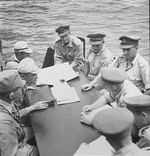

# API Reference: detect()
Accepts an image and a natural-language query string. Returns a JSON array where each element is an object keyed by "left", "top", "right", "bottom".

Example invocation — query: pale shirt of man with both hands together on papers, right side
[{"left": 104, "top": 80, "right": 142, "bottom": 107}]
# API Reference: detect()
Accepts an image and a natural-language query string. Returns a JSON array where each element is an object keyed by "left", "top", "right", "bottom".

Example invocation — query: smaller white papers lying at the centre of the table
[{"left": 51, "top": 82, "right": 80, "bottom": 105}]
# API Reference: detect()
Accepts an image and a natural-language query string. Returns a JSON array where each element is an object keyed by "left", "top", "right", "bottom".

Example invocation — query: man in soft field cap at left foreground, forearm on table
[{"left": 0, "top": 70, "right": 48, "bottom": 156}]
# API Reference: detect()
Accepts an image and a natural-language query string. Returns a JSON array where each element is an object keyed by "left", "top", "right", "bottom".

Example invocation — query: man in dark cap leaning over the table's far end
[{"left": 55, "top": 26, "right": 83, "bottom": 69}]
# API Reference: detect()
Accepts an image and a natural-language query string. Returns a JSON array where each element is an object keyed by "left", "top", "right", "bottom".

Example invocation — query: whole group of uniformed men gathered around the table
[{"left": 0, "top": 26, "right": 150, "bottom": 156}]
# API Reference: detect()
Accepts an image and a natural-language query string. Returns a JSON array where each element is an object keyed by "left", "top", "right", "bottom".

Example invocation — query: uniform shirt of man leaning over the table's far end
[{"left": 55, "top": 35, "right": 83, "bottom": 69}]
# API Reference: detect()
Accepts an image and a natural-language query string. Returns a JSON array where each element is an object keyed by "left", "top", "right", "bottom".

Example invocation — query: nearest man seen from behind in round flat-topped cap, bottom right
[{"left": 92, "top": 108, "right": 150, "bottom": 156}]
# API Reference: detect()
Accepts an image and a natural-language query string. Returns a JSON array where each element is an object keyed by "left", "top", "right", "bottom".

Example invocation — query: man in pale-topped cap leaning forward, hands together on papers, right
[{"left": 81, "top": 67, "right": 142, "bottom": 124}]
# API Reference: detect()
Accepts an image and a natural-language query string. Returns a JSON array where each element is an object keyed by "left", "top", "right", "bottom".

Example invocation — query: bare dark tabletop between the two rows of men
[{"left": 30, "top": 73, "right": 100, "bottom": 156}]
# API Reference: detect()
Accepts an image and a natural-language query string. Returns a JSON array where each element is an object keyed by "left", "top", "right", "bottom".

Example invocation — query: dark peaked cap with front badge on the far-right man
[{"left": 119, "top": 36, "right": 141, "bottom": 49}]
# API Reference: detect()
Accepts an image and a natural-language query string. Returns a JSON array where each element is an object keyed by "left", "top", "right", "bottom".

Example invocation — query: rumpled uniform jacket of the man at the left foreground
[{"left": 0, "top": 100, "right": 38, "bottom": 156}]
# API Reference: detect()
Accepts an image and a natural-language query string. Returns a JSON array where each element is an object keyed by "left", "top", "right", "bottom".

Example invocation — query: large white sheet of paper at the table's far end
[{"left": 37, "top": 62, "right": 79, "bottom": 86}]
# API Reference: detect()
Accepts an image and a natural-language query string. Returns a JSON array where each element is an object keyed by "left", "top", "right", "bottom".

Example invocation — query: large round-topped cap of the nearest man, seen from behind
[{"left": 92, "top": 108, "right": 134, "bottom": 139}]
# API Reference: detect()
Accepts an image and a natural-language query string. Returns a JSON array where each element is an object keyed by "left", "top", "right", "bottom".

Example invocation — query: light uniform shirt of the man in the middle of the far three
[{"left": 86, "top": 45, "right": 113, "bottom": 81}]
